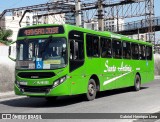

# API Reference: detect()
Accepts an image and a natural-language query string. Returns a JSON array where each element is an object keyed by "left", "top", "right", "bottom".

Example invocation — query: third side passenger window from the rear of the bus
[{"left": 131, "top": 43, "right": 139, "bottom": 60}]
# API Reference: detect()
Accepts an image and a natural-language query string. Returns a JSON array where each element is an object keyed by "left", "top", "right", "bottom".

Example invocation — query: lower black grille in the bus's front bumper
[{"left": 20, "top": 85, "right": 52, "bottom": 93}]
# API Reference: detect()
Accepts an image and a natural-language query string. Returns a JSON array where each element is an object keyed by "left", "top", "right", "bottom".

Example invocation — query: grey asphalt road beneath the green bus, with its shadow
[{"left": 0, "top": 79, "right": 160, "bottom": 121}]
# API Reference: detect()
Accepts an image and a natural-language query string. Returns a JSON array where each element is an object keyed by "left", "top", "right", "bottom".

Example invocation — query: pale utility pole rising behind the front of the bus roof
[{"left": 75, "top": 0, "right": 82, "bottom": 27}]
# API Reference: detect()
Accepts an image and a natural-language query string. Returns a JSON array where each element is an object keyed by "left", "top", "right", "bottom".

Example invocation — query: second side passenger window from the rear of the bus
[{"left": 139, "top": 45, "right": 146, "bottom": 60}]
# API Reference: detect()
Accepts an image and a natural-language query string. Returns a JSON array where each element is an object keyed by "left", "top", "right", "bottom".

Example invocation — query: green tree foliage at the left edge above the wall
[{"left": 0, "top": 29, "right": 13, "bottom": 45}]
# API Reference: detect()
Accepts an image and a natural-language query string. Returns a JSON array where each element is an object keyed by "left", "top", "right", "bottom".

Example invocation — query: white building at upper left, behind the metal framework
[{"left": 0, "top": 11, "right": 72, "bottom": 41}]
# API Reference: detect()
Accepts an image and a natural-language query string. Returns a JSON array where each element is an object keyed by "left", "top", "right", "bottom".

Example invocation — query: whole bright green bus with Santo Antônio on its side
[{"left": 9, "top": 24, "right": 154, "bottom": 100}]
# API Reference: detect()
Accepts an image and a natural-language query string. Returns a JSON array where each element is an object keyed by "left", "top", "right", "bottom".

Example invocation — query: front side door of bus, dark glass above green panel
[{"left": 69, "top": 31, "right": 86, "bottom": 94}]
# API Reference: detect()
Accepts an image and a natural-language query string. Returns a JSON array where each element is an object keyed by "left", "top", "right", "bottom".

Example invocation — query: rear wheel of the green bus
[{"left": 134, "top": 74, "right": 141, "bottom": 91}]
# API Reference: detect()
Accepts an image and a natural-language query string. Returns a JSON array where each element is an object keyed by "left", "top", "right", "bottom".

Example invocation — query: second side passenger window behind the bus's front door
[{"left": 101, "top": 38, "right": 112, "bottom": 58}]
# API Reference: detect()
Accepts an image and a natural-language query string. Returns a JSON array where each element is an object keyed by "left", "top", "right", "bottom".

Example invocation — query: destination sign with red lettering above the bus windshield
[{"left": 18, "top": 26, "right": 64, "bottom": 37}]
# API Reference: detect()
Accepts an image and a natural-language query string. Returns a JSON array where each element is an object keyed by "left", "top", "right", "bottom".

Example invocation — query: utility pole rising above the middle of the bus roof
[{"left": 98, "top": 0, "right": 104, "bottom": 31}]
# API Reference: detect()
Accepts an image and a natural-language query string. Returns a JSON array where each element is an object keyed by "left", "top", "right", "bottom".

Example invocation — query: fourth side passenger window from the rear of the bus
[{"left": 123, "top": 42, "right": 131, "bottom": 59}]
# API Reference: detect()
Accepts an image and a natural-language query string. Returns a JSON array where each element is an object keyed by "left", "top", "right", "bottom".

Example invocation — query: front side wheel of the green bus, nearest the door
[{"left": 86, "top": 79, "right": 97, "bottom": 101}]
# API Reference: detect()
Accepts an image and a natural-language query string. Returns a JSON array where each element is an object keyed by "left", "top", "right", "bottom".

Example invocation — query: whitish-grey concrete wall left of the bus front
[{"left": 0, "top": 46, "right": 15, "bottom": 93}]
